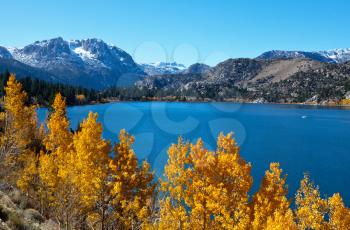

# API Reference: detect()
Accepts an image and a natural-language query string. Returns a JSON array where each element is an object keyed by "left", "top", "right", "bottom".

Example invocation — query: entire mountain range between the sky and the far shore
[{"left": 0, "top": 37, "right": 350, "bottom": 102}]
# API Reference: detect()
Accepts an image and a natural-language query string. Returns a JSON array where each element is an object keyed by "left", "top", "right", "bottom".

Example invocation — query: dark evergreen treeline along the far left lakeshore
[{"left": 0, "top": 71, "right": 224, "bottom": 106}]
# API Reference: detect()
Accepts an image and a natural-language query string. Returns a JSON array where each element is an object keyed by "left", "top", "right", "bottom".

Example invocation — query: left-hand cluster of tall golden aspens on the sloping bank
[{"left": 1, "top": 75, "right": 156, "bottom": 229}]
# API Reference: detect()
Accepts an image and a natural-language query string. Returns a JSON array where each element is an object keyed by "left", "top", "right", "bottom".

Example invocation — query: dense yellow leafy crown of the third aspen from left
[{"left": 69, "top": 112, "right": 111, "bottom": 207}]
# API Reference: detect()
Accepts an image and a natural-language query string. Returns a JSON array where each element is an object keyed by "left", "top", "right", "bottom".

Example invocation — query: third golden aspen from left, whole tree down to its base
[{"left": 68, "top": 112, "right": 112, "bottom": 229}]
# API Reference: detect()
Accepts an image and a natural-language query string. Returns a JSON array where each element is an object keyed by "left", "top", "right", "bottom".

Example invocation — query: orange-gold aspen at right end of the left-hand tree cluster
[{"left": 110, "top": 130, "right": 156, "bottom": 229}]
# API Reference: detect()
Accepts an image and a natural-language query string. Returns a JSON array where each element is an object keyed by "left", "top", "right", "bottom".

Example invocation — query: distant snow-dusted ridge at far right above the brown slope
[{"left": 257, "top": 49, "right": 350, "bottom": 63}]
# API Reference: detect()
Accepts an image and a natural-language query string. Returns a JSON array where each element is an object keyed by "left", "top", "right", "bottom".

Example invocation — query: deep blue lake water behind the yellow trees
[{"left": 38, "top": 102, "right": 350, "bottom": 206}]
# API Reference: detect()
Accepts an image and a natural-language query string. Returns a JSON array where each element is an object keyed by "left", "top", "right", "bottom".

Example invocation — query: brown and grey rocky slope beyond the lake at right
[{"left": 136, "top": 58, "right": 350, "bottom": 103}]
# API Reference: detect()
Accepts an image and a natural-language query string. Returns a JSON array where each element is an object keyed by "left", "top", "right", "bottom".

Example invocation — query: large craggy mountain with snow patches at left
[{"left": 0, "top": 37, "right": 146, "bottom": 89}]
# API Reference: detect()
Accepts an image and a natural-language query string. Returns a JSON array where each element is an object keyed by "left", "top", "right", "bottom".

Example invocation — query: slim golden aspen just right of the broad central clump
[{"left": 252, "top": 163, "right": 289, "bottom": 229}]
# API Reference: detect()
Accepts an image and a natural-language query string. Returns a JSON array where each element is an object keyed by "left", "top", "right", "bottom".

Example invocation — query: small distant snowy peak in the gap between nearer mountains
[{"left": 139, "top": 62, "right": 186, "bottom": 76}]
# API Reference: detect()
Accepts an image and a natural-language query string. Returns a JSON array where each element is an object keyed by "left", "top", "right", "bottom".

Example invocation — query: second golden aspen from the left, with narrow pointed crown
[{"left": 39, "top": 93, "right": 83, "bottom": 229}]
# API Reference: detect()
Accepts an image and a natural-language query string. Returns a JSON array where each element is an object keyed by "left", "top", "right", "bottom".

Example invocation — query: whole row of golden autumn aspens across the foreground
[{"left": 0, "top": 75, "right": 350, "bottom": 230}]
